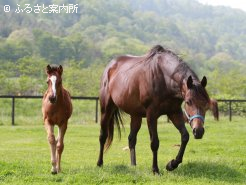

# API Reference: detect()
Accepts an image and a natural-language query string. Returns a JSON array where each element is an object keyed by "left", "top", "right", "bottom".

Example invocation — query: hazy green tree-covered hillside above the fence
[{"left": 0, "top": 0, "right": 246, "bottom": 98}]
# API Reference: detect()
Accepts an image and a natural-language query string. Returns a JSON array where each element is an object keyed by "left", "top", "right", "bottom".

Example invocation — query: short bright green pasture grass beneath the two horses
[{"left": 0, "top": 118, "right": 246, "bottom": 185}]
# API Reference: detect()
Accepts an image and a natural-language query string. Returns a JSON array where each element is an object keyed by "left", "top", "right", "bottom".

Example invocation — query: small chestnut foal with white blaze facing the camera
[{"left": 42, "top": 65, "right": 72, "bottom": 174}]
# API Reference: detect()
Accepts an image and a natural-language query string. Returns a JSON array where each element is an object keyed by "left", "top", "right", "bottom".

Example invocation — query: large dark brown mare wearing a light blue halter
[{"left": 97, "top": 45, "right": 218, "bottom": 173}]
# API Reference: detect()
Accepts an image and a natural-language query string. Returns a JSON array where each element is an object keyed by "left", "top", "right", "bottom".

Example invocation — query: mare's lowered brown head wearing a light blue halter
[{"left": 184, "top": 76, "right": 218, "bottom": 139}]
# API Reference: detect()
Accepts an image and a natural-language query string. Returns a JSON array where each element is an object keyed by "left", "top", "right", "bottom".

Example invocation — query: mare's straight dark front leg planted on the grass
[{"left": 147, "top": 112, "right": 159, "bottom": 174}]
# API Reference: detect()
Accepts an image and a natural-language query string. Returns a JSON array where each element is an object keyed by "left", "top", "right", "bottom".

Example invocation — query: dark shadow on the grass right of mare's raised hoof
[{"left": 175, "top": 162, "right": 245, "bottom": 183}]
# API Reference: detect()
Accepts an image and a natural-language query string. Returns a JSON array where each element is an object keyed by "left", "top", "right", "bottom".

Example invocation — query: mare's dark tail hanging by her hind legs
[{"left": 104, "top": 107, "right": 124, "bottom": 151}]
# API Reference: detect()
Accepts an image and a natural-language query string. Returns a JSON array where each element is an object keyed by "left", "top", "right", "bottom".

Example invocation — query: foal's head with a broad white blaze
[{"left": 46, "top": 65, "right": 63, "bottom": 104}]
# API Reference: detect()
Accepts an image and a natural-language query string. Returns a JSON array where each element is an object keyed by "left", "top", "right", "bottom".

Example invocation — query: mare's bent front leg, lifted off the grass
[{"left": 166, "top": 111, "right": 189, "bottom": 171}]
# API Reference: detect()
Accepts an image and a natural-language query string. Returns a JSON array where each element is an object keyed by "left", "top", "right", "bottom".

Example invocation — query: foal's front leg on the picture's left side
[{"left": 45, "top": 123, "right": 57, "bottom": 174}]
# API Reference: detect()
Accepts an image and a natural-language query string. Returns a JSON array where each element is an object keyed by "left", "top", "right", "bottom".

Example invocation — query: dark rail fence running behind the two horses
[{"left": 0, "top": 96, "right": 246, "bottom": 125}]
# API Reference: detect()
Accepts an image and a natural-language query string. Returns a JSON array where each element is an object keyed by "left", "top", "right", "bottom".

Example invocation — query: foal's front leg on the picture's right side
[{"left": 56, "top": 122, "right": 67, "bottom": 172}]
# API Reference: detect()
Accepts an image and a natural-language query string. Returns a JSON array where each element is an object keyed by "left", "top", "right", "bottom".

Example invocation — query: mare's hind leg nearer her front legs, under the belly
[{"left": 128, "top": 116, "right": 142, "bottom": 166}]
